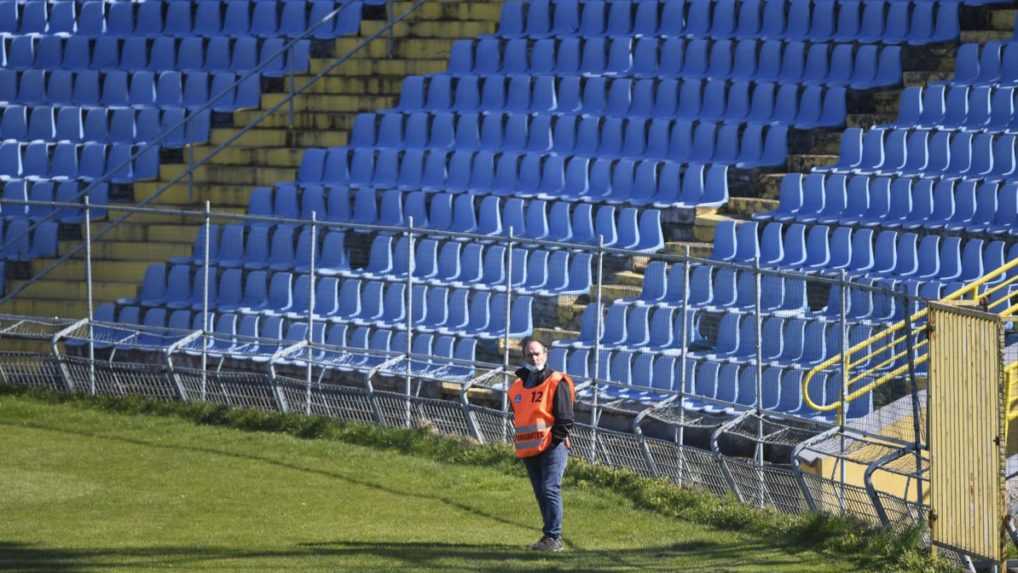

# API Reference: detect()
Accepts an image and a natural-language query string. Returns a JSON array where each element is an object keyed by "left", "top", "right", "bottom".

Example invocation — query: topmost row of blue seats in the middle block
[{"left": 499, "top": 0, "right": 960, "bottom": 44}]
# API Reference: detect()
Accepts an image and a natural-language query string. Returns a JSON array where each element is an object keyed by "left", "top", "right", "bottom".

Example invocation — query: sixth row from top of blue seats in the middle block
[{"left": 247, "top": 185, "right": 664, "bottom": 245}]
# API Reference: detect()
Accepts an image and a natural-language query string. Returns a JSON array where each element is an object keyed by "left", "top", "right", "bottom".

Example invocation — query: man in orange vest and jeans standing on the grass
[{"left": 509, "top": 338, "right": 576, "bottom": 552}]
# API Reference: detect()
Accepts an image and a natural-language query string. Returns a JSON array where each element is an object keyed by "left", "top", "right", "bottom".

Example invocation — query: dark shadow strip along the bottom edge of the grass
[{"left": 0, "top": 540, "right": 807, "bottom": 573}]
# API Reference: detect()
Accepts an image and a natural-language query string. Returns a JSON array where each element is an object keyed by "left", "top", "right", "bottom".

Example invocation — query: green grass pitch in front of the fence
[{"left": 0, "top": 395, "right": 875, "bottom": 572}]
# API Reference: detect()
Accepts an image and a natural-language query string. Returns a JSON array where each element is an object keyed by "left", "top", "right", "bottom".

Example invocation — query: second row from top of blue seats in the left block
[{"left": 0, "top": 36, "right": 310, "bottom": 77}]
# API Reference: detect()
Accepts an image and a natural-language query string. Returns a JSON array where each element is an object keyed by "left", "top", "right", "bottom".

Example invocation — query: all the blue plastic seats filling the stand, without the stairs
[{"left": 0, "top": 0, "right": 1018, "bottom": 419}]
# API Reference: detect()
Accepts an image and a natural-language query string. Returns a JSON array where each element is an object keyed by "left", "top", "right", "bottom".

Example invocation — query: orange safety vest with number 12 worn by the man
[{"left": 509, "top": 373, "right": 576, "bottom": 458}]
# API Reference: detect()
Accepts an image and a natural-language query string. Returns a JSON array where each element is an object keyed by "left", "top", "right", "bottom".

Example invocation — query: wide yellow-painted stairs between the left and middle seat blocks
[{"left": 0, "top": 0, "right": 501, "bottom": 318}]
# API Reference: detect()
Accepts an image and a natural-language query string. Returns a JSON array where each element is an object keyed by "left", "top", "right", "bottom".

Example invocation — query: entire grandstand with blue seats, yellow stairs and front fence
[{"left": 0, "top": 0, "right": 1018, "bottom": 565}]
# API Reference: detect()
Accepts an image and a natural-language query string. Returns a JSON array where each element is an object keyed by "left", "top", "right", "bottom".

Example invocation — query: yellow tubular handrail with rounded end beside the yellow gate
[{"left": 802, "top": 259, "right": 1018, "bottom": 417}]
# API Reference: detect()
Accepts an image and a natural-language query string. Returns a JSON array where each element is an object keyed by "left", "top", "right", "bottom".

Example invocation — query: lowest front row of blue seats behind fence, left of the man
[{"left": 88, "top": 304, "right": 476, "bottom": 380}]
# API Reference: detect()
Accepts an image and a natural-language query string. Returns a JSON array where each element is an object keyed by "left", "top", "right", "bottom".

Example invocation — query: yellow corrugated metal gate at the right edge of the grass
[{"left": 928, "top": 303, "right": 1006, "bottom": 562}]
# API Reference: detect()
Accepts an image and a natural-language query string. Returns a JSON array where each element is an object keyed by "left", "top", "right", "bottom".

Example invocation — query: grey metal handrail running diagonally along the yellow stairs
[{"left": 0, "top": 0, "right": 432, "bottom": 303}]
